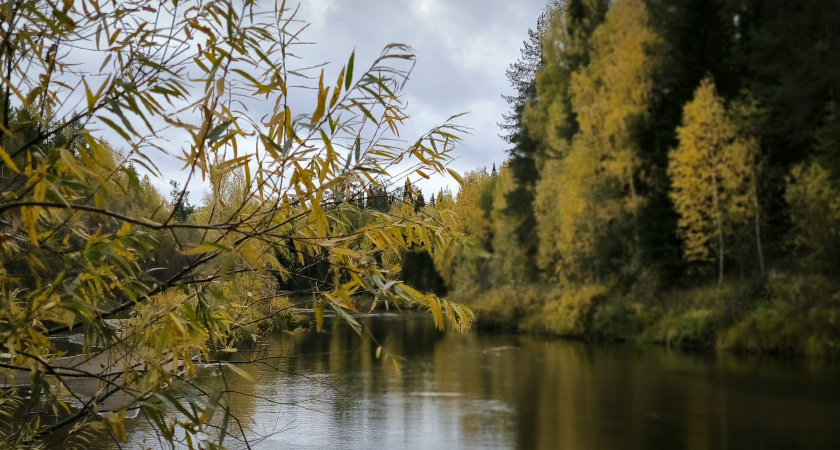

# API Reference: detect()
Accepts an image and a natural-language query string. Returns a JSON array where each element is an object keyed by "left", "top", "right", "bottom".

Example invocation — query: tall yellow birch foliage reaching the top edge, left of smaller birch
[{"left": 534, "top": 0, "right": 661, "bottom": 282}]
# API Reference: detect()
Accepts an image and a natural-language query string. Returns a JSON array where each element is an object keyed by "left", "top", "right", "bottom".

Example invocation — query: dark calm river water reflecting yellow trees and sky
[{"left": 116, "top": 314, "right": 840, "bottom": 449}]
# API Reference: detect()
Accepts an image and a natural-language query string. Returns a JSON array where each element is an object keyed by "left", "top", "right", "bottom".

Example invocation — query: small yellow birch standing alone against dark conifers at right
[{"left": 668, "top": 78, "right": 763, "bottom": 284}]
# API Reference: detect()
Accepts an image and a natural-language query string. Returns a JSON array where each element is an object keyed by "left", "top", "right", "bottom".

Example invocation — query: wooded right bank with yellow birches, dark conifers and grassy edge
[{"left": 437, "top": 0, "right": 840, "bottom": 354}]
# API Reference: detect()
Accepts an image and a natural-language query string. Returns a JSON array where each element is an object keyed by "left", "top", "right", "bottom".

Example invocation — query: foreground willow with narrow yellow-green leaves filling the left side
[{"left": 0, "top": 0, "right": 472, "bottom": 447}]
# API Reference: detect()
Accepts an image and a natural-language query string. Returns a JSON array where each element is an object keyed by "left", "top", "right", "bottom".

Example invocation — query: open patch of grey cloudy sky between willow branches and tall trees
[{"left": 292, "top": 0, "right": 546, "bottom": 195}]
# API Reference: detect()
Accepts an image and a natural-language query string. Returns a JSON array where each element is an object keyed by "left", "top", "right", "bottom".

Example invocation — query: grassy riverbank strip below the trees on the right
[{"left": 455, "top": 273, "right": 840, "bottom": 356}]
